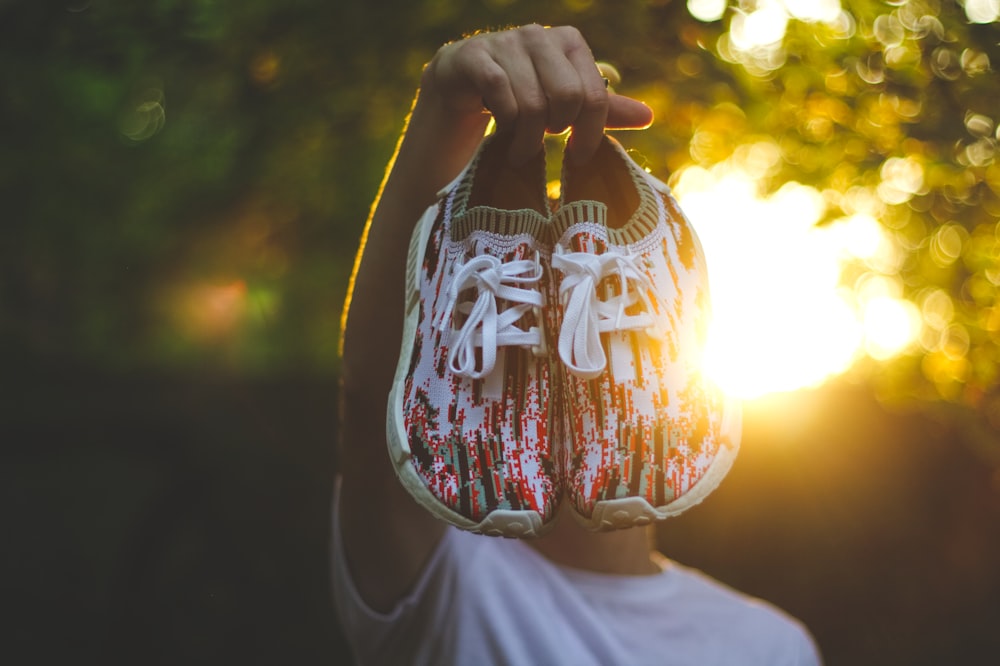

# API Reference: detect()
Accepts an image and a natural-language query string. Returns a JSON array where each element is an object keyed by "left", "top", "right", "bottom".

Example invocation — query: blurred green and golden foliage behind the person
[{"left": 0, "top": 0, "right": 1000, "bottom": 440}]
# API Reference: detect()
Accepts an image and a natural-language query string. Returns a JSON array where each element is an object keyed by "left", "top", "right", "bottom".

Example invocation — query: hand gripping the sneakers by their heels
[{"left": 422, "top": 25, "right": 653, "bottom": 164}]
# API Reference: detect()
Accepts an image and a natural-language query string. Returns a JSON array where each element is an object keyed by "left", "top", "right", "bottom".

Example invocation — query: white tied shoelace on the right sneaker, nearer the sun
[{"left": 552, "top": 248, "right": 659, "bottom": 379}]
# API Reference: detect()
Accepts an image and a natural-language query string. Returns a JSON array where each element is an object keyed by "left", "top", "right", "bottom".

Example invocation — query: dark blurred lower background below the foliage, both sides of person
[{"left": 7, "top": 368, "right": 1000, "bottom": 665}]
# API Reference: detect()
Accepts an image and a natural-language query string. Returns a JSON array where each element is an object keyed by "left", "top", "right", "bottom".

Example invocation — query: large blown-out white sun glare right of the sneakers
[{"left": 674, "top": 145, "right": 920, "bottom": 398}]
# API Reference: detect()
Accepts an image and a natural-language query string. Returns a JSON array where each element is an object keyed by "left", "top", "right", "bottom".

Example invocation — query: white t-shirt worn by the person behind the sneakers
[{"left": 332, "top": 488, "right": 821, "bottom": 666}]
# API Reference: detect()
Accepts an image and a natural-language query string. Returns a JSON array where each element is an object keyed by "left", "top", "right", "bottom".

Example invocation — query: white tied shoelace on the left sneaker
[{"left": 438, "top": 254, "right": 543, "bottom": 379}]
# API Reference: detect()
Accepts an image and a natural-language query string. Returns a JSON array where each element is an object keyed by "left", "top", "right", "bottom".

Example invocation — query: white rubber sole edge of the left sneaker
[{"left": 386, "top": 206, "right": 543, "bottom": 538}]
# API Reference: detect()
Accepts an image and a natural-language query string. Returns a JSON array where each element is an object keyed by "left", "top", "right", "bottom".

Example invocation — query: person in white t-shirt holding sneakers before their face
[{"left": 332, "top": 25, "right": 820, "bottom": 666}]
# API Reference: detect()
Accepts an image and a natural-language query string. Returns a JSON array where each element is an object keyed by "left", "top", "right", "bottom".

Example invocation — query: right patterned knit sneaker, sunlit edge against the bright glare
[{"left": 550, "top": 137, "right": 741, "bottom": 529}]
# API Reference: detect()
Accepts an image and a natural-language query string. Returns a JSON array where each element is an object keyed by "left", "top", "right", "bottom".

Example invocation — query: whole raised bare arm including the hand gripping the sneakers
[{"left": 340, "top": 25, "right": 652, "bottom": 610}]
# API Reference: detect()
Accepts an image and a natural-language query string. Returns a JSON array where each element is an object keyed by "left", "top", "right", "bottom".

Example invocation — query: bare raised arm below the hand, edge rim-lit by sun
[{"left": 339, "top": 71, "right": 488, "bottom": 610}]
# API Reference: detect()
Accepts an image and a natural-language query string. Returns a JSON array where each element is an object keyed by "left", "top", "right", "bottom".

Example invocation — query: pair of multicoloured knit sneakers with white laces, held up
[{"left": 387, "top": 134, "right": 740, "bottom": 537}]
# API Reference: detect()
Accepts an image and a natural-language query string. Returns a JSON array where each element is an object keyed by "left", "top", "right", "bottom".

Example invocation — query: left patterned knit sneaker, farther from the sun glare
[{"left": 387, "top": 134, "right": 561, "bottom": 537}]
